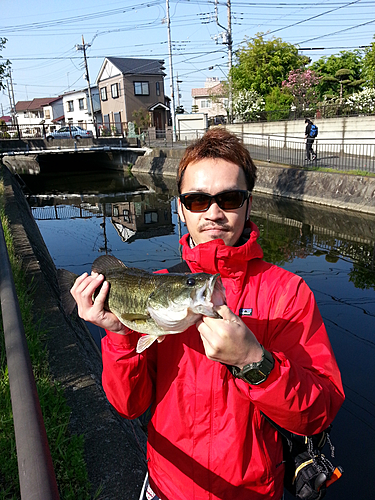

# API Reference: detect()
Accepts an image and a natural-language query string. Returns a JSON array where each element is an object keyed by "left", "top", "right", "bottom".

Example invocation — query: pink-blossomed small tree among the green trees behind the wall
[{"left": 282, "top": 69, "right": 320, "bottom": 110}]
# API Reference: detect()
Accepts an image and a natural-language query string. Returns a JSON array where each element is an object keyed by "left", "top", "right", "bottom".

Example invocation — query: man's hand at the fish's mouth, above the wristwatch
[{"left": 197, "top": 305, "right": 263, "bottom": 369}]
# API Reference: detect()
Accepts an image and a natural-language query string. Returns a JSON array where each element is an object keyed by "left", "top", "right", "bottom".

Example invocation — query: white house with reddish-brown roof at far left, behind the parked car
[{"left": 16, "top": 96, "right": 64, "bottom": 137}]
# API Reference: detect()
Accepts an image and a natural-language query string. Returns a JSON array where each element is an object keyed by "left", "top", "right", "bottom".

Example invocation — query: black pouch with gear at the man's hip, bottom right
[{"left": 264, "top": 415, "right": 343, "bottom": 500}]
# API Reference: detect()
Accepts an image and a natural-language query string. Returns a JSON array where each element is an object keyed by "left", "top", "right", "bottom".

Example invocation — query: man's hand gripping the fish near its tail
[{"left": 70, "top": 273, "right": 127, "bottom": 335}]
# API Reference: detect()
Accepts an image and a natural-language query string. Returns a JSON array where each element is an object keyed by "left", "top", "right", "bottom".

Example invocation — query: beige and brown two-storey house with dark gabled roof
[{"left": 96, "top": 57, "right": 169, "bottom": 133}]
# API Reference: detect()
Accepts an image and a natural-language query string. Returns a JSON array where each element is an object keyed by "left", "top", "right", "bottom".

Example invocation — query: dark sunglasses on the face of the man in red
[{"left": 180, "top": 189, "right": 251, "bottom": 212}]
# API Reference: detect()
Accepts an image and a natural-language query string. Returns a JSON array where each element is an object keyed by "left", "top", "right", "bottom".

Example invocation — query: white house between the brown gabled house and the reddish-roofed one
[{"left": 62, "top": 86, "right": 102, "bottom": 131}]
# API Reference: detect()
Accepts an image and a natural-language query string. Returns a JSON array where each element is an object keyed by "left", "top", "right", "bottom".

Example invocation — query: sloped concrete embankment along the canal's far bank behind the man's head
[{"left": 132, "top": 149, "right": 375, "bottom": 214}]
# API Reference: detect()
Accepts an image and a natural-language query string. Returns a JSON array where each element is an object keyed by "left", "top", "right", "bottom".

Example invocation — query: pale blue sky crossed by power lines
[{"left": 0, "top": 0, "right": 375, "bottom": 114}]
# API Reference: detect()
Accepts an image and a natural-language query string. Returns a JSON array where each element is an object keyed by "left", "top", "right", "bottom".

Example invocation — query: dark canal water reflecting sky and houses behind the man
[{"left": 22, "top": 169, "right": 375, "bottom": 500}]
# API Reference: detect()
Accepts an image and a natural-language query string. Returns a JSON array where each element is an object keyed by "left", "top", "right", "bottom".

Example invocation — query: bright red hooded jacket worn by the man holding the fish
[{"left": 102, "top": 224, "right": 344, "bottom": 500}]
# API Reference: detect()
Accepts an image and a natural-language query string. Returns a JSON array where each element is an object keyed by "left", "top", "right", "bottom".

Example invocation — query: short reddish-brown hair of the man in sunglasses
[{"left": 177, "top": 128, "right": 256, "bottom": 193}]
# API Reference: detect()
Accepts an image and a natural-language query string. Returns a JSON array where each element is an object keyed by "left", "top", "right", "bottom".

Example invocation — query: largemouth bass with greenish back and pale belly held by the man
[{"left": 58, "top": 255, "right": 225, "bottom": 353}]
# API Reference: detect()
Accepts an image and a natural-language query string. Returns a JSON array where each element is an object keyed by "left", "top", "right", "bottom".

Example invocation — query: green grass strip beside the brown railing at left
[{"left": 0, "top": 178, "right": 100, "bottom": 500}]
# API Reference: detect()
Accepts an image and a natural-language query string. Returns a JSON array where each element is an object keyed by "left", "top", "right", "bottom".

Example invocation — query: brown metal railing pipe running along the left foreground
[{"left": 0, "top": 224, "right": 59, "bottom": 500}]
